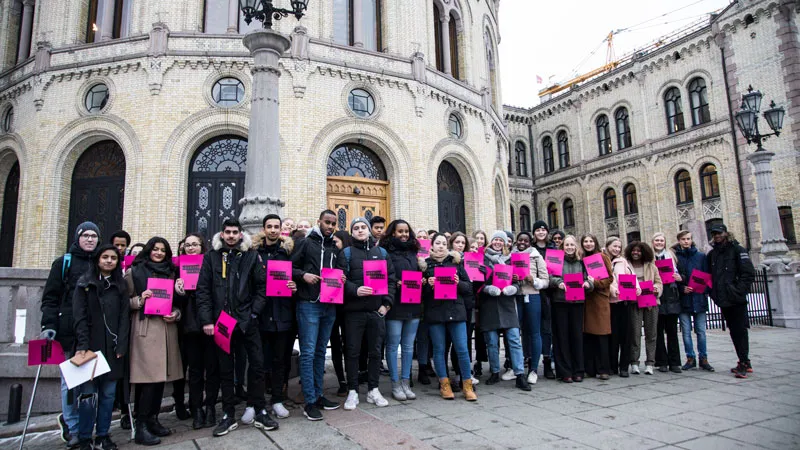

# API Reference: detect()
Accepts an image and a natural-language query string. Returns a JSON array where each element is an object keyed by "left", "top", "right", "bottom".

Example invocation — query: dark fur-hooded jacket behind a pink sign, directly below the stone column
[{"left": 253, "top": 233, "right": 295, "bottom": 332}]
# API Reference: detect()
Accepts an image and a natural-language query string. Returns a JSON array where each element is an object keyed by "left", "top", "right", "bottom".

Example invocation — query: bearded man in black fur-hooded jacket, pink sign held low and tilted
[{"left": 196, "top": 219, "right": 278, "bottom": 436}]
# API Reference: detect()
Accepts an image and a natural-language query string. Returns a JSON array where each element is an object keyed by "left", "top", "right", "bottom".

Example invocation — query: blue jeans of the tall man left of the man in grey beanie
[{"left": 297, "top": 301, "right": 336, "bottom": 405}]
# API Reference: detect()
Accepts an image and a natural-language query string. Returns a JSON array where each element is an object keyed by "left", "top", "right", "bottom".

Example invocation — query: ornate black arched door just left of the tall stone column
[{"left": 186, "top": 136, "right": 247, "bottom": 239}]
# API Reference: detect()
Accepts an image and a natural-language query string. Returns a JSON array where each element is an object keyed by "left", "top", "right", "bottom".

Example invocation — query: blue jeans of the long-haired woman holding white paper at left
[{"left": 75, "top": 377, "right": 117, "bottom": 441}]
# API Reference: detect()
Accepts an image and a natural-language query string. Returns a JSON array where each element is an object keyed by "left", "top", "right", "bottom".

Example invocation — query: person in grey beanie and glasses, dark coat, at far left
[{"left": 40, "top": 222, "right": 100, "bottom": 447}]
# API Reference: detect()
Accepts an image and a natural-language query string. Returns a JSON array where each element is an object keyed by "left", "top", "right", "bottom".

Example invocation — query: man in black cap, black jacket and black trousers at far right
[{"left": 707, "top": 224, "right": 756, "bottom": 378}]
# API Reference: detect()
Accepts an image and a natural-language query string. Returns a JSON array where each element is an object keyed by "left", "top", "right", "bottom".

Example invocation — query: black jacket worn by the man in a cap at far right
[{"left": 707, "top": 241, "right": 756, "bottom": 308}]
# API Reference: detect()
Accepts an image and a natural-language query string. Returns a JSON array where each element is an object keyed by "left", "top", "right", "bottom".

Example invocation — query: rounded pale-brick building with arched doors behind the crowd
[{"left": 0, "top": 0, "right": 509, "bottom": 268}]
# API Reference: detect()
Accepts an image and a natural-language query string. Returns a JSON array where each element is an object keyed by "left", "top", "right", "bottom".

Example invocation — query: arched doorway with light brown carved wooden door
[{"left": 328, "top": 143, "right": 391, "bottom": 231}]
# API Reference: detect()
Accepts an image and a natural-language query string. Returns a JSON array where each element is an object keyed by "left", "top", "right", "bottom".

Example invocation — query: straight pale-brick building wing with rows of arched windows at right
[{"left": 504, "top": 0, "right": 800, "bottom": 256}]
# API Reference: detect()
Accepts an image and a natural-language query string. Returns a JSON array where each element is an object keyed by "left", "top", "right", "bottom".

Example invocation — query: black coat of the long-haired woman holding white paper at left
[{"left": 72, "top": 272, "right": 131, "bottom": 380}]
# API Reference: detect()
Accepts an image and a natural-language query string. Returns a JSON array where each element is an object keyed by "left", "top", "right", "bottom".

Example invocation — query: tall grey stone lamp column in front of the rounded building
[{"left": 239, "top": 29, "right": 290, "bottom": 233}]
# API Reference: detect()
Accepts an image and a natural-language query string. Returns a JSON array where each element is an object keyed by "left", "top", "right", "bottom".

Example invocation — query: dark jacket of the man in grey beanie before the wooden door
[{"left": 336, "top": 238, "right": 397, "bottom": 313}]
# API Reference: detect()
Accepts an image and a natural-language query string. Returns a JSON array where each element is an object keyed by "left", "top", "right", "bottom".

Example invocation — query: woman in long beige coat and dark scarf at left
[{"left": 125, "top": 237, "right": 183, "bottom": 445}]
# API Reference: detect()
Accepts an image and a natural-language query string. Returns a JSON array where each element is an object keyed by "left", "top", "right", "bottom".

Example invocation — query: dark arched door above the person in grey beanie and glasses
[{"left": 67, "top": 141, "right": 125, "bottom": 248}]
